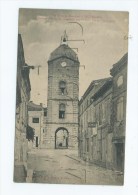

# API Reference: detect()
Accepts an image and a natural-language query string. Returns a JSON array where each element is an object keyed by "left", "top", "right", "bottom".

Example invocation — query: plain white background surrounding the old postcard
[{"left": 0, "top": 0, "right": 138, "bottom": 195}]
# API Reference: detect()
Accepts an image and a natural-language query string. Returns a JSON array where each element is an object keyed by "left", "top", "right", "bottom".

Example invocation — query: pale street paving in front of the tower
[{"left": 28, "top": 149, "right": 123, "bottom": 185}]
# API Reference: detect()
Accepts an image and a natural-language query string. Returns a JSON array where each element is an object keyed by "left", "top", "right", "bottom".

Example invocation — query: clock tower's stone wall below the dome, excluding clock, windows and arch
[{"left": 45, "top": 57, "right": 79, "bottom": 149}]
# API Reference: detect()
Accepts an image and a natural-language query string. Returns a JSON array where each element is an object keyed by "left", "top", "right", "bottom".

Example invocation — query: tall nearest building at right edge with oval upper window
[{"left": 110, "top": 54, "right": 128, "bottom": 171}]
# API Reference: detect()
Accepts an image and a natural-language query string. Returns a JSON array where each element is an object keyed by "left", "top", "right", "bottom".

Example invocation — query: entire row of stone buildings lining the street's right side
[{"left": 78, "top": 54, "right": 127, "bottom": 172}]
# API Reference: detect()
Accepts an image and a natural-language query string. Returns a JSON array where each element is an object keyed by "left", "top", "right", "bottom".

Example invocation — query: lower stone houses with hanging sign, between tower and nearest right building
[{"left": 79, "top": 78, "right": 113, "bottom": 168}]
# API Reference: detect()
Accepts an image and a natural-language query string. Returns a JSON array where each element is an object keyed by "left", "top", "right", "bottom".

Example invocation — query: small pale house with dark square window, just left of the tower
[{"left": 28, "top": 101, "right": 47, "bottom": 148}]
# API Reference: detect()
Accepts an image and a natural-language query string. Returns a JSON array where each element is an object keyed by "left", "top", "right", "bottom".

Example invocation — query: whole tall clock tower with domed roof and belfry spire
[{"left": 45, "top": 32, "right": 80, "bottom": 149}]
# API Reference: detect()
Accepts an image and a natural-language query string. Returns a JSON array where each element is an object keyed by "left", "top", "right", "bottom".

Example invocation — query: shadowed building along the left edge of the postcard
[{"left": 14, "top": 34, "right": 31, "bottom": 182}]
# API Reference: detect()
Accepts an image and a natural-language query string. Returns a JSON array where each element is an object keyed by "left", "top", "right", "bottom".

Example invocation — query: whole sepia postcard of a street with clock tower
[{"left": 13, "top": 8, "right": 129, "bottom": 186}]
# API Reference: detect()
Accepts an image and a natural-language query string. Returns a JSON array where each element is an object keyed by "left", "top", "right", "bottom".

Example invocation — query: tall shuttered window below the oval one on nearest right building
[{"left": 117, "top": 97, "right": 124, "bottom": 121}]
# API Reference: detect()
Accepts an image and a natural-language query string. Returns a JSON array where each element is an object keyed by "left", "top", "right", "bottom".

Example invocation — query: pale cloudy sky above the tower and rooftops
[{"left": 19, "top": 9, "right": 129, "bottom": 106}]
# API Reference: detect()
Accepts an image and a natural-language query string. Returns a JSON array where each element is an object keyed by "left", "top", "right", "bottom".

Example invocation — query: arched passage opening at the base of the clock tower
[{"left": 55, "top": 127, "right": 69, "bottom": 149}]
